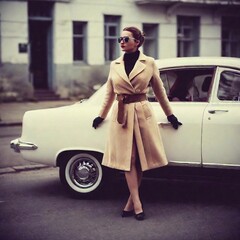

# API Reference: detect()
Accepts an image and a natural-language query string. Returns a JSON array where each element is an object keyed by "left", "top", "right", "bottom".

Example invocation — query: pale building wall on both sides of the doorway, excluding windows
[{"left": 0, "top": 0, "right": 236, "bottom": 101}]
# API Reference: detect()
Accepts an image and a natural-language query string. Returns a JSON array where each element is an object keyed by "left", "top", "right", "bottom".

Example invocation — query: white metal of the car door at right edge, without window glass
[{"left": 202, "top": 68, "right": 240, "bottom": 166}]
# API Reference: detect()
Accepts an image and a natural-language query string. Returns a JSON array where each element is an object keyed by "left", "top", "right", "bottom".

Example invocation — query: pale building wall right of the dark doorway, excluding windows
[{"left": 54, "top": 0, "right": 221, "bottom": 97}]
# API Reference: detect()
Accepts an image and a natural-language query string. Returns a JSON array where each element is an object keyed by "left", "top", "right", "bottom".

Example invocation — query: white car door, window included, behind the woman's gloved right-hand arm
[{"left": 150, "top": 67, "right": 215, "bottom": 166}]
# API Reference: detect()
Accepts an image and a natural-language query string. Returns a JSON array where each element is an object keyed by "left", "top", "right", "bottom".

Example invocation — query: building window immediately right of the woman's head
[{"left": 143, "top": 24, "right": 158, "bottom": 59}]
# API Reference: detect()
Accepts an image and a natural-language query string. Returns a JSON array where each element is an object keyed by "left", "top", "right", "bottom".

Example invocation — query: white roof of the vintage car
[{"left": 155, "top": 57, "right": 240, "bottom": 69}]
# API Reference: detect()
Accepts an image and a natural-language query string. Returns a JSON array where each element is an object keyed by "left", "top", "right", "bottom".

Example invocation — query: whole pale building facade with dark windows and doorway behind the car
[{"left": 0, "top": 0, "right": 240, "bottom": 99}]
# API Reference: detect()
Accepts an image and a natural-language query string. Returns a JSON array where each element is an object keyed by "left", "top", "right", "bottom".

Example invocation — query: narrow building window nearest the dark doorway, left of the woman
[{"left": 73, "top": 21, "right": 87, "bottom": 62}]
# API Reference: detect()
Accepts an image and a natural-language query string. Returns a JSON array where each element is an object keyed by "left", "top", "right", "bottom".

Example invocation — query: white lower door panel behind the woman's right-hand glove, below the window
[{"left": 154, "top": 102, "right": 207, "bottom": 165}]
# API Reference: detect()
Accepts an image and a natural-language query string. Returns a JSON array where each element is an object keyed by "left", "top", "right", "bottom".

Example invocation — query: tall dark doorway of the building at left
[{"left": 29, "top": 20, "right": 51, "bottom": 89}]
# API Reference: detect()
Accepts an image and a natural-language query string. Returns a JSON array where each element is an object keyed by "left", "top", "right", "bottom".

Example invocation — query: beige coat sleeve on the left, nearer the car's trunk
[{"left": 99, "top": 62, "right": 115, "bottom": 118}]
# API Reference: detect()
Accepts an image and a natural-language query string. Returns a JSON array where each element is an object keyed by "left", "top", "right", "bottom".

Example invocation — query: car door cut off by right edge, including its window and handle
[{"left": 202, "top": 67, "right": 240, "bottom": 166}]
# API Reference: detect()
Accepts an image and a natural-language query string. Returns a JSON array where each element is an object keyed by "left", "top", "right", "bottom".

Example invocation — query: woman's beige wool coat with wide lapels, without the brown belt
[{"left": 99, "top": 53, "right": 172, "bottom": 171}]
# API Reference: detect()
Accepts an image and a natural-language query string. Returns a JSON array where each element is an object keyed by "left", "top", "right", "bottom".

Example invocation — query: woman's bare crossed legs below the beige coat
[{"left": 124, "top": 139, "right": 143, "bottom": 214}]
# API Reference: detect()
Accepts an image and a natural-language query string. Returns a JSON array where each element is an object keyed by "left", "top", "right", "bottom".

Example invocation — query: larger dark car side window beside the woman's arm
[{"left": 149, "top": 67, "right": 215, "bottom": 102}]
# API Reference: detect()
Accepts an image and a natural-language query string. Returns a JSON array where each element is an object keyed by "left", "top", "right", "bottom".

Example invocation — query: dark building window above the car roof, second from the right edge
[{"left": 177, "top": 16, "right": 199, "bottom": 57}]
